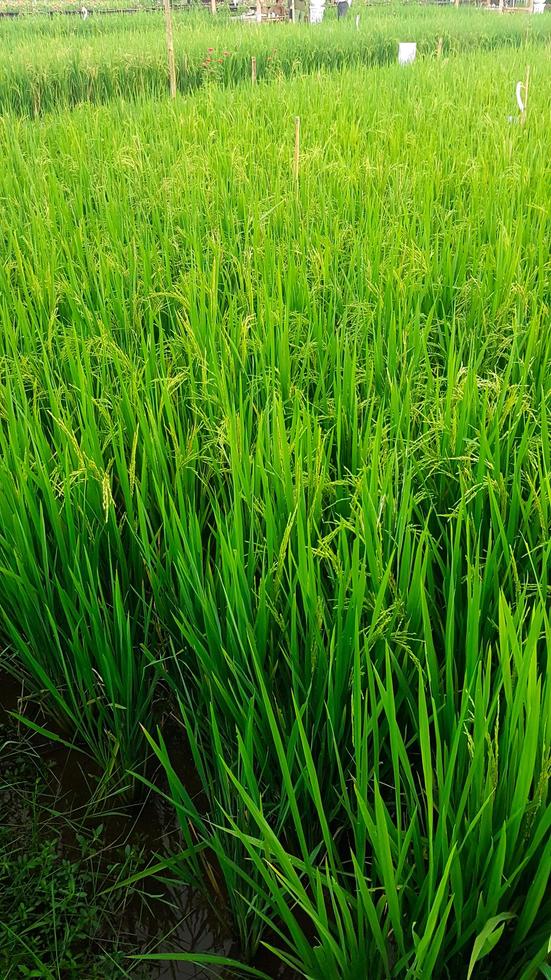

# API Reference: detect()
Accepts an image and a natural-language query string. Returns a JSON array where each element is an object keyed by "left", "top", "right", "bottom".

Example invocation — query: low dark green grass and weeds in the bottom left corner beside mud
[{"left": 0, "top": 722, "right": 147, "bottom": 980}]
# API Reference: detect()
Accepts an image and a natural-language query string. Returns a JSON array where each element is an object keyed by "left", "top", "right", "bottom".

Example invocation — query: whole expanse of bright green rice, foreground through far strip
[{"left": 0, "top": 9, "right": 551, "bottom": 980}]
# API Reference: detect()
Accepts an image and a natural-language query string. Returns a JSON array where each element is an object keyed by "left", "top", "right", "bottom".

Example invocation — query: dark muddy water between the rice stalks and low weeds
[{"left": 0, "top": 674, "right": 233, "bottom": 980}]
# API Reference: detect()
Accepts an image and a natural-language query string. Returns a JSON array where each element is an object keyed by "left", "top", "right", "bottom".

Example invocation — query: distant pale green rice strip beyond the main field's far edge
[{"left": 0, "top": 4, "right": 551, "bottom": 116}]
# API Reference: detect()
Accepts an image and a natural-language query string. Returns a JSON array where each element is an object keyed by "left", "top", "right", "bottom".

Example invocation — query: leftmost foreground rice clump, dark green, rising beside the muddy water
[{"left": 0, "top": 424, "right": 157, "bottom": 772}]
